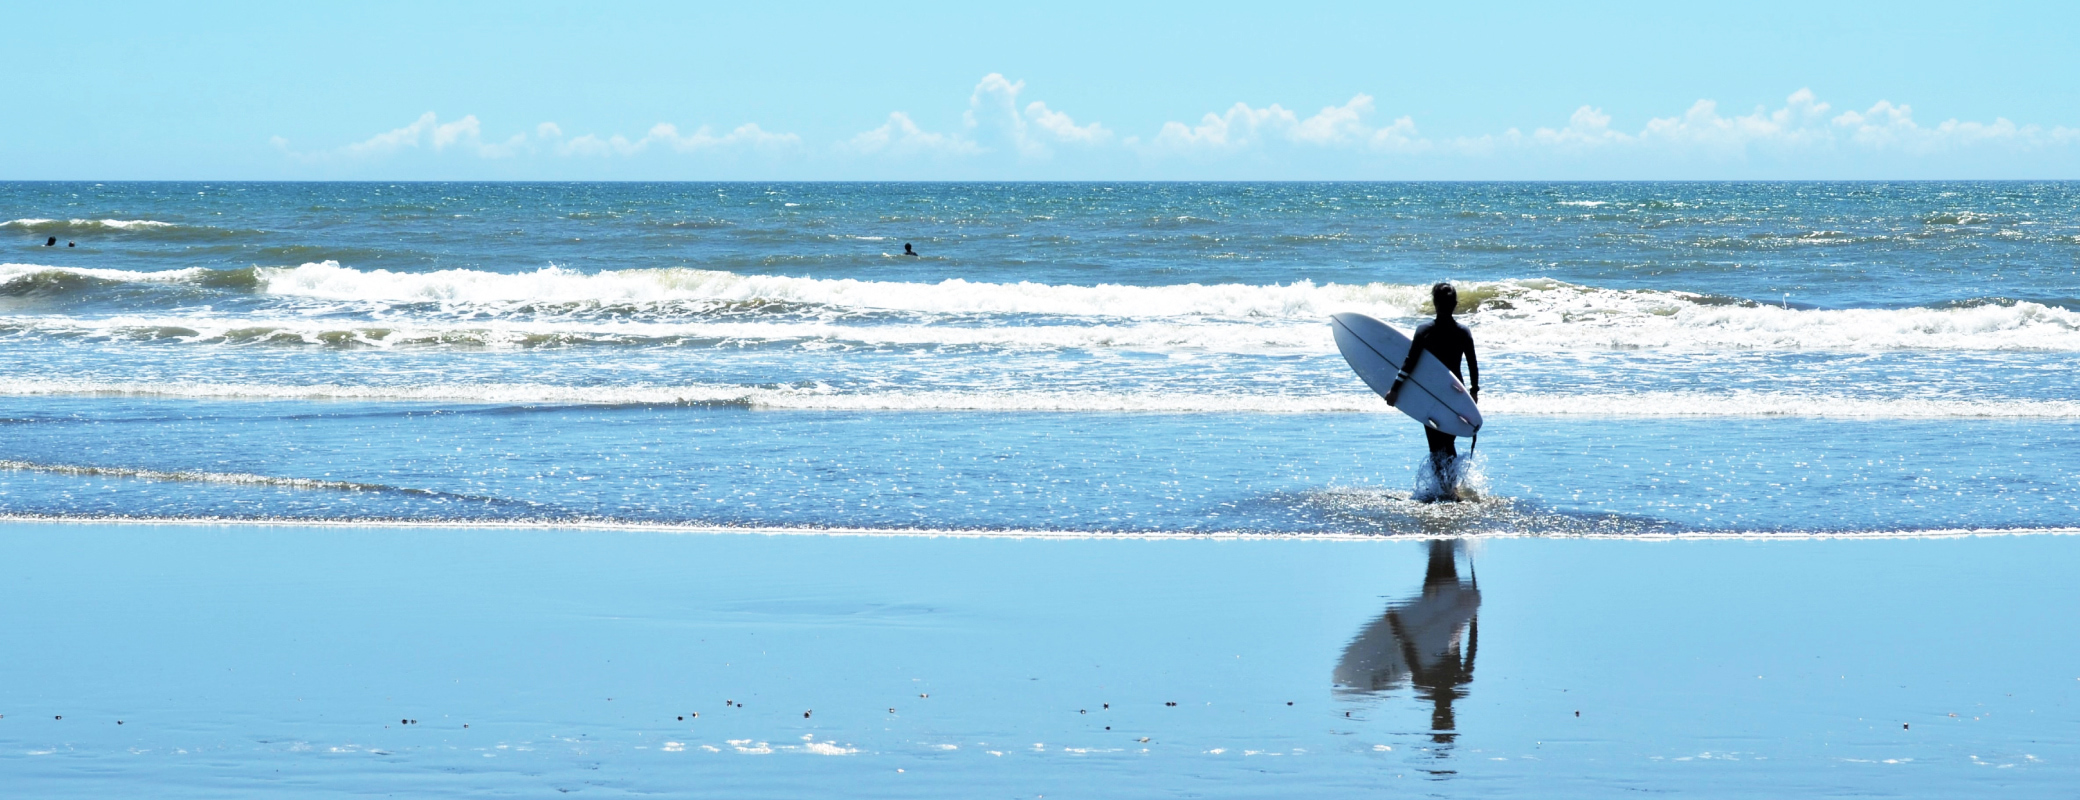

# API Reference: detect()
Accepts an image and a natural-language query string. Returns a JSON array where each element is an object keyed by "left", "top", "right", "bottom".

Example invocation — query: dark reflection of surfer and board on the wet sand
[{"left": 1335, "top": 540, "right": 1481, "bottom": 744}]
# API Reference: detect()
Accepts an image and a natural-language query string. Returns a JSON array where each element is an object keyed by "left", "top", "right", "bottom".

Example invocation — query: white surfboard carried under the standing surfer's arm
[{"left": 1329, "top": 314, "right": 1481, "bottom": 436}]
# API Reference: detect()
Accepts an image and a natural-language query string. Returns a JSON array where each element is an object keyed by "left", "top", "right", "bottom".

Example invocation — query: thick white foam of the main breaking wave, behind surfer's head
[{"left": 247, "top": 262, "right": 2080, "bottom": 351}]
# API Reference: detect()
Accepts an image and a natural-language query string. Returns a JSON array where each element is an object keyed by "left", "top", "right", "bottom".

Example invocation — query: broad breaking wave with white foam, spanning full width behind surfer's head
[{"left": 0, "top": 262, "right": 2080, "bottom": 353}]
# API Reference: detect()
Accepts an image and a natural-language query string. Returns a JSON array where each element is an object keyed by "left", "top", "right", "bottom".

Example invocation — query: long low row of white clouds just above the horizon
[{"left": 284, "top": 82, "right": 2080, "bottom": 172}]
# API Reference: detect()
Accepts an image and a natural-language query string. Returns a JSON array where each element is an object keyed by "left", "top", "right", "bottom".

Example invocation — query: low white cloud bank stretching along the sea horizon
[{"left": 270, "top": 73, "right": 2080, "bottom": 179}]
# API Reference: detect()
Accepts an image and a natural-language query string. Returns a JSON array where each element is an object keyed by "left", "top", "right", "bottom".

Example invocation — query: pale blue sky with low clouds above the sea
[{"left": 0, "top": 0, "right": 2080, "bottom": 181}]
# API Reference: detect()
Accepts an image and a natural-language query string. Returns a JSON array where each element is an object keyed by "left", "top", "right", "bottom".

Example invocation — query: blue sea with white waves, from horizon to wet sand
[{"left": 0, "top": 183, "right": 2080, "bottom": 529}]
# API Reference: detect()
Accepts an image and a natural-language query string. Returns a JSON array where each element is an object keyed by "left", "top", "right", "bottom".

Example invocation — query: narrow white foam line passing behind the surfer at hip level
[{"left": 0, "top": 378, "right": 2080, "bottom": 420}]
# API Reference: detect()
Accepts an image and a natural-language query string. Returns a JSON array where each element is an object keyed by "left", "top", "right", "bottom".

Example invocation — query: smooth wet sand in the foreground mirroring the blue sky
[{"left": 0, "top": 524, "right": 2080, "bottom": 798}]
